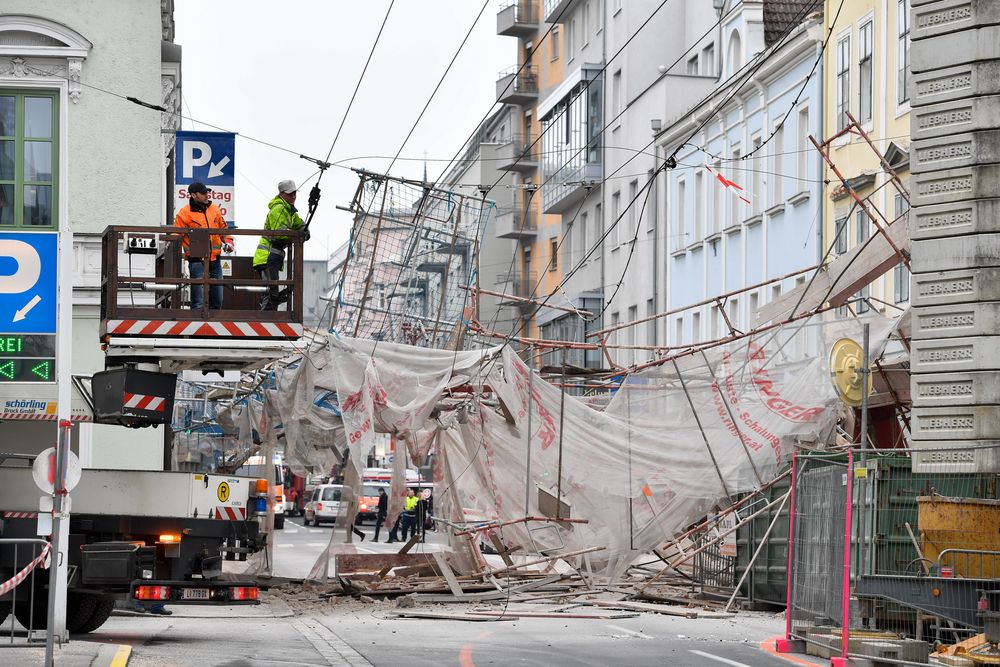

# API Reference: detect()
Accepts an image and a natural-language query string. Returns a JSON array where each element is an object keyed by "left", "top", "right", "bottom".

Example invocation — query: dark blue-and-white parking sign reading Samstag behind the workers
[{"left": 174, "top": 130, "right": 236, "bottom": 226}]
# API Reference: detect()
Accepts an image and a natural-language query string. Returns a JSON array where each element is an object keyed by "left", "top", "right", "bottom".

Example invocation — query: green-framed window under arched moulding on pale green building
[{"left": 0, "top": 90, "right": 59, "bottom": 228}]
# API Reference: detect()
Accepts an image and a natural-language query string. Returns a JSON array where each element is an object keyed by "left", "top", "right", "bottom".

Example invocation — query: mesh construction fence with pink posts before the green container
[{"left": 786, "top": 447, "right": 1000, "bottom": 664}]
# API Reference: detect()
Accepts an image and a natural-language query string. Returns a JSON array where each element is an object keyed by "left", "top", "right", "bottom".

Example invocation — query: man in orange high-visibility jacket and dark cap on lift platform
[{"left": 174, "top": 181, "right": 233, "bottom": 310}]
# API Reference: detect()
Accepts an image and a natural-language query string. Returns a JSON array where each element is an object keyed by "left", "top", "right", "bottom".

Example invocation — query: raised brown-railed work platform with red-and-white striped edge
[{"left": 100, "top": 226, "right": 303, "bottom": 372}]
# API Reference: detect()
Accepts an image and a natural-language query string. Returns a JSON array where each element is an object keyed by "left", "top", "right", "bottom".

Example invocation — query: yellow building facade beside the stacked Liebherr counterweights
[{"left": 817, "top": 0, "right": 910, "bottom": 315}]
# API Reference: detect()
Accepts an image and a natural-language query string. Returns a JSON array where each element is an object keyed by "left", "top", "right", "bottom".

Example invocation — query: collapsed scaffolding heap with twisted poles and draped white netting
[{"left": 191, "top": 124, "right": 924, "bottom": 620}]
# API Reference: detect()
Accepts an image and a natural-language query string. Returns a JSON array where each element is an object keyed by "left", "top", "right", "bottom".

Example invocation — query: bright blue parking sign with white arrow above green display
[{"left": 0, "top": 232, "right": 59, "bottom": 334}]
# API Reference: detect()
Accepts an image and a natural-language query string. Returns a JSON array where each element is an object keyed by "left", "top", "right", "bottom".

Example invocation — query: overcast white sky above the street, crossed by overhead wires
[{"left": 174, "top": 0, "right": 516, "bottom": 259}]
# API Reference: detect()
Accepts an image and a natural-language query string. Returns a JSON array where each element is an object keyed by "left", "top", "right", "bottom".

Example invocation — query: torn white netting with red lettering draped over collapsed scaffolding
[{"left": 279, "top": 316, "right": 893, "bottom": 577}]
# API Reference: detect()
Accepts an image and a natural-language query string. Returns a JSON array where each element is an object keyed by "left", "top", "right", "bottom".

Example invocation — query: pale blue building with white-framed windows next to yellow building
[{"left": 657, "top": 0, "right": 824, "bottom": 358}]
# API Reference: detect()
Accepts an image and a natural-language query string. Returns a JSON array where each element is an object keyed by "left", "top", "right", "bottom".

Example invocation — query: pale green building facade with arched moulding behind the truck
[{"left": 0, "top": 0, "right": 180, "bottom": 469}]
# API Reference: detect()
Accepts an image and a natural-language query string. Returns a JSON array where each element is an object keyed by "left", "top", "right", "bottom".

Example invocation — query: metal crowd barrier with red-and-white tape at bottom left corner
[{"left": 0, "top": 538, "right": 49, "bottom": 648}]
